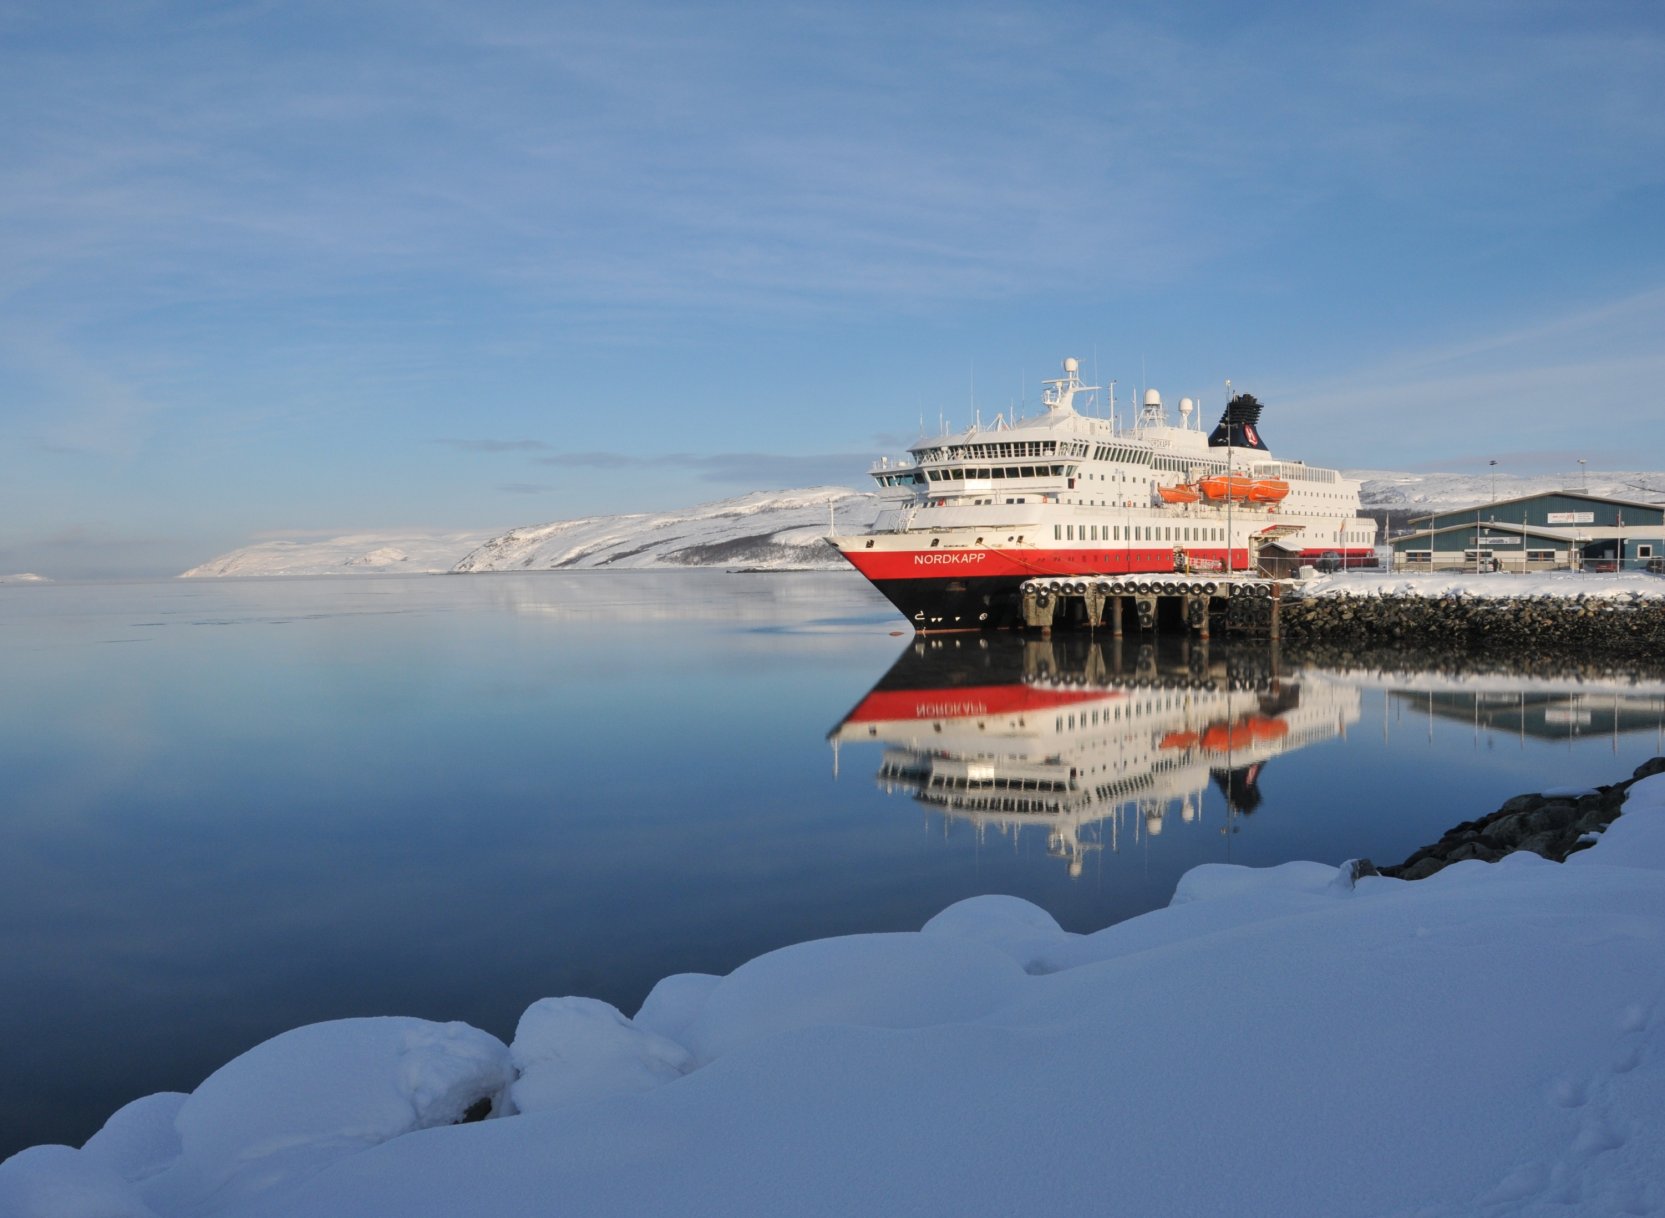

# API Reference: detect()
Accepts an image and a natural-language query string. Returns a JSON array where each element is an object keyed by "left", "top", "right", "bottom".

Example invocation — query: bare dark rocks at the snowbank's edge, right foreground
[{"left": 1378, "top": 757, "right": 1665, "bottom": 880}]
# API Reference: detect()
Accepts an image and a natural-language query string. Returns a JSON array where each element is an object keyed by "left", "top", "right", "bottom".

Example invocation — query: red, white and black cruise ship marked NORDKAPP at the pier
[{"left": 828, "top": 359, "right": 1377, "bottom": 632}]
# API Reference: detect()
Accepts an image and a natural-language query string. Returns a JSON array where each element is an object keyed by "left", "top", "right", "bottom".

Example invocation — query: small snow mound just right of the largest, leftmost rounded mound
[{"left": 509, "top": 998, "right": 693, "bottom": 1113}]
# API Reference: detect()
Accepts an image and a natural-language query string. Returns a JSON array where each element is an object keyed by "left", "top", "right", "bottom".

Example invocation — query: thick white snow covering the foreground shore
[{"left": 0, "top": 775, "right": 1665, "bottom": 1218}]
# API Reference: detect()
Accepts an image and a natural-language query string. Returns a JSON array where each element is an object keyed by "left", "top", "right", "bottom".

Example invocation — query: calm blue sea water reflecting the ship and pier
[{"left": 0, "top": 572, "right": 1665, "bottom": 1155}]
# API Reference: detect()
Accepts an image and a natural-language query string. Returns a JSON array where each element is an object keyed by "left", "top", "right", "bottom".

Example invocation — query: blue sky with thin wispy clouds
[{"left": 0, "top": 0, "right": 1665, "bottom": 577}]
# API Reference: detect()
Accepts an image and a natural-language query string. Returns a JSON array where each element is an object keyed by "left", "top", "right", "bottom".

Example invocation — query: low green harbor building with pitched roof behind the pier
[{"left": 1389, "top": 491, "right": 1665, "bottom": 572}]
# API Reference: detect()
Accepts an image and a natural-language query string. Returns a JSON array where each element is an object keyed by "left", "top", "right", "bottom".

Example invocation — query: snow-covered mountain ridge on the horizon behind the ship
[{"left": 183, "top": 471, "right": 1665, "bottom": 579}]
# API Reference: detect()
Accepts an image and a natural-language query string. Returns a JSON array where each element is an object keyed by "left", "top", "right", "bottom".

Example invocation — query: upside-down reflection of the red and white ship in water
[{"left": 833, "top": 636, "right": 1359, "bottom": 874}]
